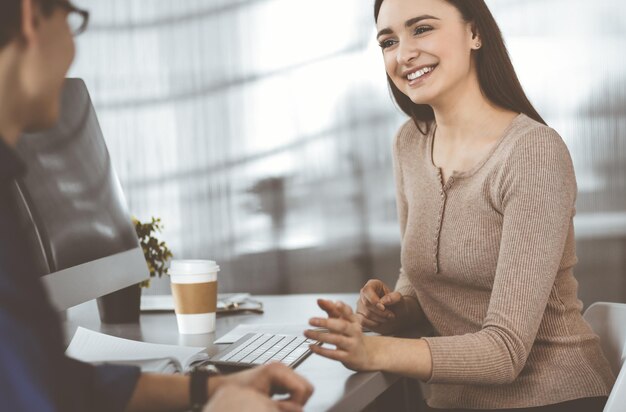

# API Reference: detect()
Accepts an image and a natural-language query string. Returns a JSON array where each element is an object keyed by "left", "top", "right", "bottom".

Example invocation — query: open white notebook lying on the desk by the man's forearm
[{"left": 65, "top": 327, "right": 208, "bottom": 373}]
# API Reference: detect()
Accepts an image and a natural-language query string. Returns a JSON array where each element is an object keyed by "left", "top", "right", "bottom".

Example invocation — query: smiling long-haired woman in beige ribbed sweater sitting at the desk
[{"left": 305, "top": 0, "right": 614, "bottom": 412}]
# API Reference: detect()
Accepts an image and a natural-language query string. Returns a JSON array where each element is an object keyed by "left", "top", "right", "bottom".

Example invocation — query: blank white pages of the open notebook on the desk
[{"left": 65, "top": 327, "right": 204, "bottom": 368}]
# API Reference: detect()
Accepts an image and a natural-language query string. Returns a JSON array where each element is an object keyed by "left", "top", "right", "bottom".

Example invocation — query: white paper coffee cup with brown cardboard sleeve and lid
[{"left": 168, "top": 260, "right": 220, "bottom": 334}]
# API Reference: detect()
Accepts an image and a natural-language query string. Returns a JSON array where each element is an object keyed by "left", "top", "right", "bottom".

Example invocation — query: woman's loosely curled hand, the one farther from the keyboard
[{"left": 356, "top": 279, "right": 407, "bottom": 335}]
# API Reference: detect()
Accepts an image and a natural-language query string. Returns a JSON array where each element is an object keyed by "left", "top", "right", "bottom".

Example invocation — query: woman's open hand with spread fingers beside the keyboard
[{"left": 304, "top": 299, "right": 378, "bottom": 371}]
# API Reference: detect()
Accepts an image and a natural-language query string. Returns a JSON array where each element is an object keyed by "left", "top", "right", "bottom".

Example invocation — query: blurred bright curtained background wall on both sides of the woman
[{"left": 70, "top": 0, "right": 626, "bottom": 304}]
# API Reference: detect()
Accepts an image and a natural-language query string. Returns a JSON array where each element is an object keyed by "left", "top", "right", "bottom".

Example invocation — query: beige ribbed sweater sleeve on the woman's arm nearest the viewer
[{"left": 425, "top": 127, "right": 576, "bottom": 384}]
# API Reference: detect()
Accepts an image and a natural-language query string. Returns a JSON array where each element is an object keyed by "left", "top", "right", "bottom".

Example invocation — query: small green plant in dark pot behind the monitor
[{"left": 98, "top": 217, "right": 172, "bottom": 323}]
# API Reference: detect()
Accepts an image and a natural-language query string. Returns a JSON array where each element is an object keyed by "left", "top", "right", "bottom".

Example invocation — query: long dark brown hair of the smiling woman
[{"left": 374, "top": 0, "right": 546, "bottom": 133}]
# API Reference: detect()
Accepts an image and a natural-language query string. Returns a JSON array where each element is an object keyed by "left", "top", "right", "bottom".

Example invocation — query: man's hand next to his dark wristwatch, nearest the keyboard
[{"left": 208, "top": 363, "right": 313, "bottom": 411}]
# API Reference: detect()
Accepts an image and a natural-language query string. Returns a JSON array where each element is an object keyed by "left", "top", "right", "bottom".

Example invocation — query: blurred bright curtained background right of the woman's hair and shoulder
[{"left": 489, "top": 0, "right": 626, "bottom": 304}]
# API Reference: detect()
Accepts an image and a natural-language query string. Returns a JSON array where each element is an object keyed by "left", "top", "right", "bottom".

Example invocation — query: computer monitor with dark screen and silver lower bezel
[{"left": 14, "top": 79, "right": 149, "bottom": 308}]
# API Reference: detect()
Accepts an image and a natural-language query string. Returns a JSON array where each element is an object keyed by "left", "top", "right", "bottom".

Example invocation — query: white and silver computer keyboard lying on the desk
[{"left": 210, "top": 333, "right": 319, "bottom": 368}]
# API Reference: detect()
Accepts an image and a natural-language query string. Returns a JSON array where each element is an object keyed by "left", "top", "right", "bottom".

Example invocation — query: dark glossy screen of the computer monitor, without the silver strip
[{"left": 17, "top": 79, "right": 139, "bottom": 272}]
